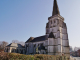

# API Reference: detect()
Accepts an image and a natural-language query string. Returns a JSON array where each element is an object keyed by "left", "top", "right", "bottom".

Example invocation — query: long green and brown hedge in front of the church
[{"left": 0, "top": 52, "right": 67, "bottom": 60}]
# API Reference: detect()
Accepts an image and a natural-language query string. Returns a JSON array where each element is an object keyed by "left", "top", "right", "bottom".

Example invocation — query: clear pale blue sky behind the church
[{"left": 0, "top": 0, "right": 80, "bottom": 47}]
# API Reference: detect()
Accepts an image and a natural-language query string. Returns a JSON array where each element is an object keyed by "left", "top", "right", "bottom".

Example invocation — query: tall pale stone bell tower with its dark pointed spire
[{"left": 46, "top": 0, "right": 70, "bottom": 57}]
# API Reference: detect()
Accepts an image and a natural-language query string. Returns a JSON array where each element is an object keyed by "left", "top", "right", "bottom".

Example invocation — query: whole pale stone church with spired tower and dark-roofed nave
[{"left": 5, "top": 0, "right": 70, "bottom": 57}]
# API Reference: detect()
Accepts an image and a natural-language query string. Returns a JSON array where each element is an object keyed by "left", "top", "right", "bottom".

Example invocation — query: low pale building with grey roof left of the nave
[{"left": 4, "top": 43, "right": 26, "bottom": 54}]
